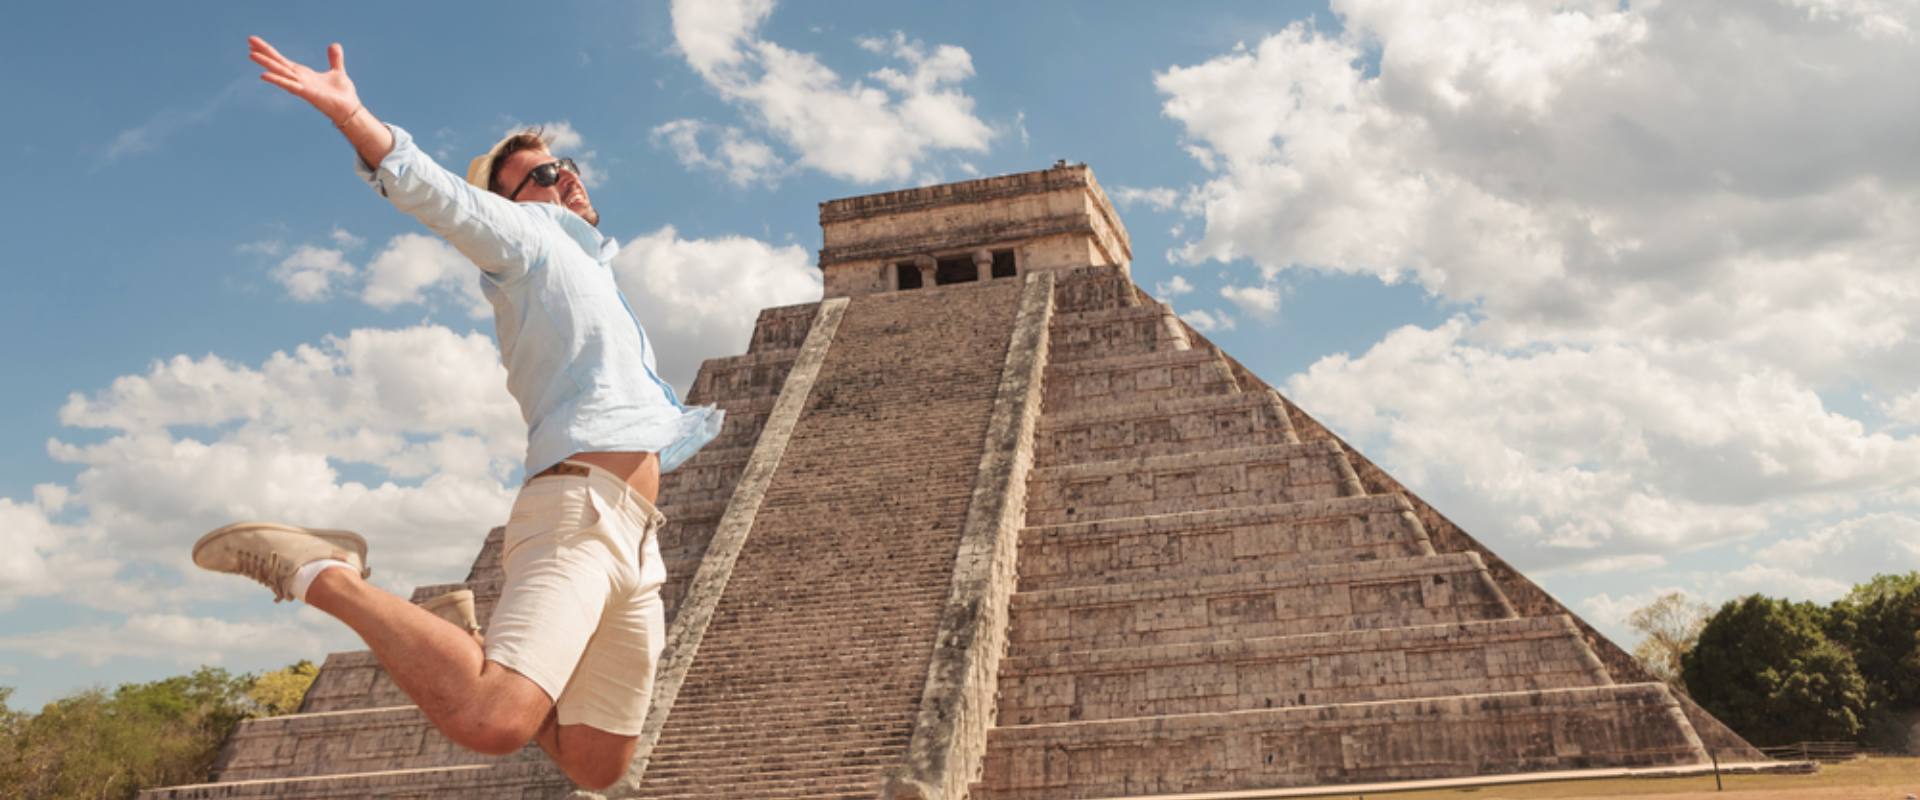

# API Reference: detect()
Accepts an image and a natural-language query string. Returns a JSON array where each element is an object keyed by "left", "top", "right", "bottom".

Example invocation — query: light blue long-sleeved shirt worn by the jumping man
[{"left": 353, "top": 125, "right": 726, "bottom": 474}]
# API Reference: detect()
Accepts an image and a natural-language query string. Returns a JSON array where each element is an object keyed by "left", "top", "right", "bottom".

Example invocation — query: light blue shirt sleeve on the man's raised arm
[{"left": 353, "top": 125, "right": 553, "bottom": 282}]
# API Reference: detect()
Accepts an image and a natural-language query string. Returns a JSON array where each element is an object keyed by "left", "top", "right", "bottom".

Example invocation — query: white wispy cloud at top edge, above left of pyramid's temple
[{"left": 672, "top": 0, "right": 993, "bottom": 182}]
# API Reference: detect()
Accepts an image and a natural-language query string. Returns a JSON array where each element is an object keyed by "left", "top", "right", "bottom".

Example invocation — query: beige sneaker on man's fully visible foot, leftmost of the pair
[{"left": 194, "top": 522, "right": 372, "bottom": 602}]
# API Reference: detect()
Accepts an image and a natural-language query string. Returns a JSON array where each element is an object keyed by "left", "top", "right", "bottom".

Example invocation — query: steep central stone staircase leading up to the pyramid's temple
[{"left": 634, "top": 280, "right": 1021, "bottom": 798}]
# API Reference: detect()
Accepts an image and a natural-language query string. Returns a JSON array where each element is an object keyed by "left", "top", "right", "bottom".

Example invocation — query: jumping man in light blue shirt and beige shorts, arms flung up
[{"left": 194, "top": 36, "right": 722, "bottom": 788}]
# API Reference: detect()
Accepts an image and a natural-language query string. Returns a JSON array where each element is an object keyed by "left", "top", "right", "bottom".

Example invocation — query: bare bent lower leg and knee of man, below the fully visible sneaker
[{"left": 307, "top": 570, "right": 553, "bottom": 756}]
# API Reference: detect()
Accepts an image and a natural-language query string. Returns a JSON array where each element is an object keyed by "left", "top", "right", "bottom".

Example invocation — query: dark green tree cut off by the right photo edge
[{"left": 1828, "top": 572, "right": 1920, "bottom": 750}]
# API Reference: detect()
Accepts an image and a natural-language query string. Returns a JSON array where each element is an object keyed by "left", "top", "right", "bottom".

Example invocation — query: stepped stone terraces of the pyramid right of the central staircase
[{"left": 972, "top": 271, "right": 1707, "bottom": 800}]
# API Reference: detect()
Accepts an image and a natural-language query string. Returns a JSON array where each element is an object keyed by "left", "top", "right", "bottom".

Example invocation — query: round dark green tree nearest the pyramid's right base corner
[{"left": 1682, "top": 595, "right": 1866, "bottom": 746}]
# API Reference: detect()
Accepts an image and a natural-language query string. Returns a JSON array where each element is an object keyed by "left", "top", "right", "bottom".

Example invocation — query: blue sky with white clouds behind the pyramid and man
[{"left": 0, "top": 0, "right": 1920, "bottom": 708}]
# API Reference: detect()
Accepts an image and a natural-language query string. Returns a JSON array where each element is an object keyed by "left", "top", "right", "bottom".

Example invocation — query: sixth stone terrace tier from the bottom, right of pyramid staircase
[{"left": 1035, "top": 391, "right": 1300, "bottom": 466}]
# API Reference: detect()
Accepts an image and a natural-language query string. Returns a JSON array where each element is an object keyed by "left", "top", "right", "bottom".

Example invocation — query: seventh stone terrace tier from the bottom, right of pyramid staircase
[{"left": 1041, "top": 347, "right": 1238, "bottom": 414}]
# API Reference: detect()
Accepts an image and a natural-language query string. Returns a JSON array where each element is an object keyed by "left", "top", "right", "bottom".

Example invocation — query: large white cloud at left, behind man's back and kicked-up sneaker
[{"left": 30, "top": 326, "right": 526, "bottom": 610}]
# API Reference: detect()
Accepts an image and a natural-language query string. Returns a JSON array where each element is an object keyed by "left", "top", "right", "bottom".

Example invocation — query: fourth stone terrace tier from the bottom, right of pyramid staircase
[{"left": 1020, "top": 495, "right": 1434, "bottom": 591}]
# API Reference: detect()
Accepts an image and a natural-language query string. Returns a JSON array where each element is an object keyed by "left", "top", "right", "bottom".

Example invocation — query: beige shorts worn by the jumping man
[{"left": 486, "top": 462, "right": 666, "bottom": 737}]
